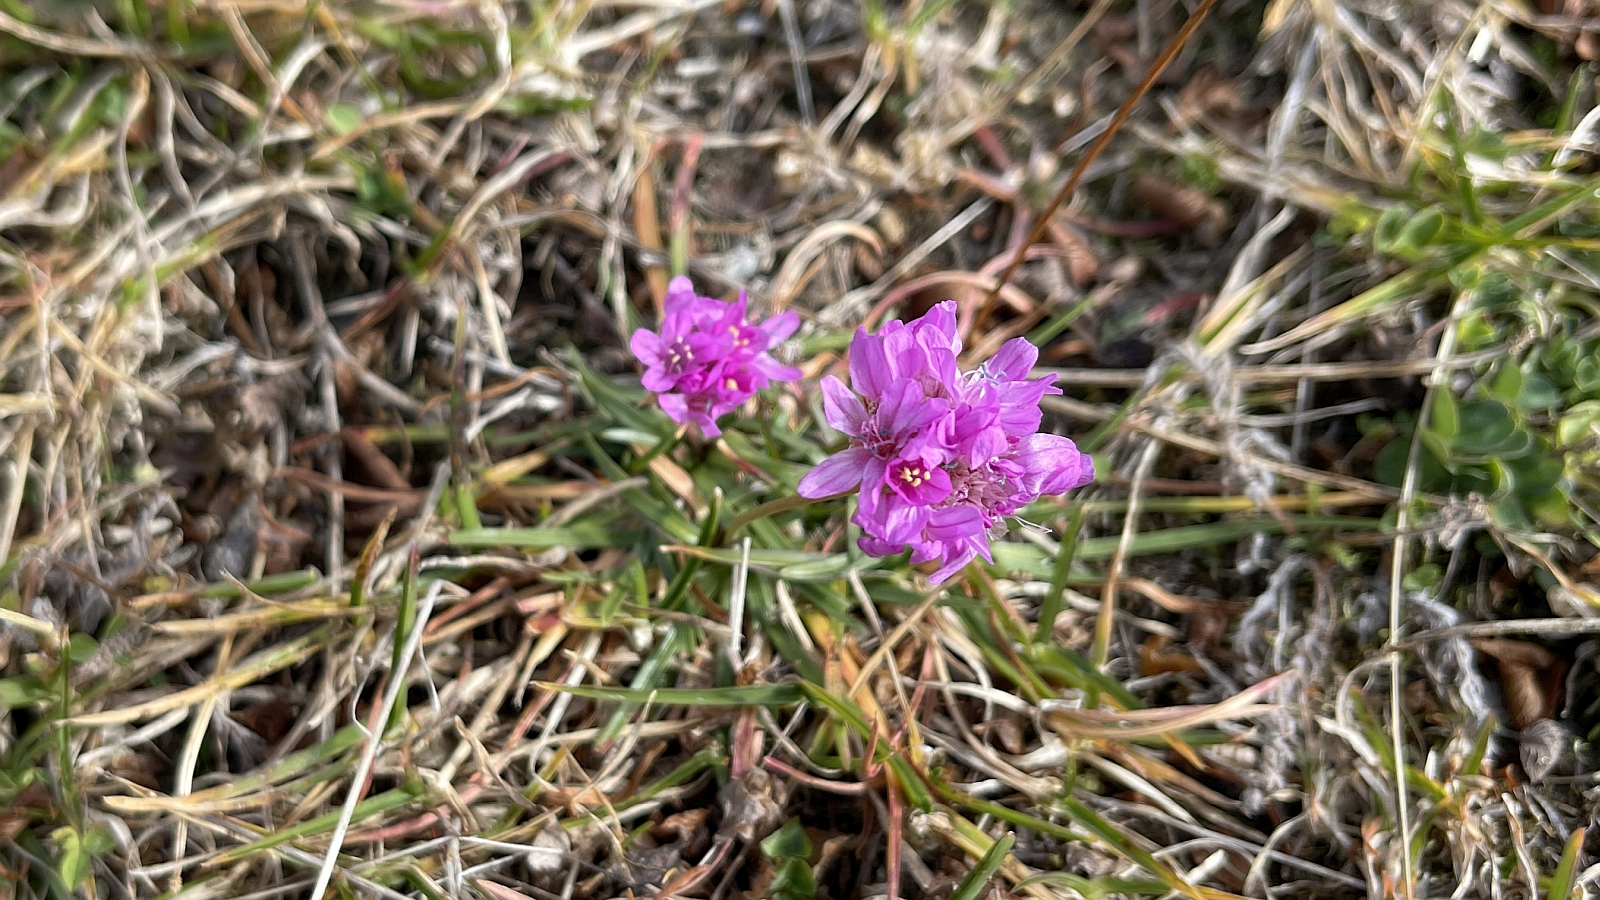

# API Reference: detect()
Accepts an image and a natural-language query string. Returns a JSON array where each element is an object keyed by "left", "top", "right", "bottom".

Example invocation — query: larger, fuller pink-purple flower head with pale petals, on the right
[{"left": 800, "top": 301, "right": 1094, "bottom": 583}]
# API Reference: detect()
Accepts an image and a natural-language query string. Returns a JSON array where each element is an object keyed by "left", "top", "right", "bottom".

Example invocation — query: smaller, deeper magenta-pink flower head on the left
[{"left": 629, "top": 275, "right": 800, "bottom": 437}]
